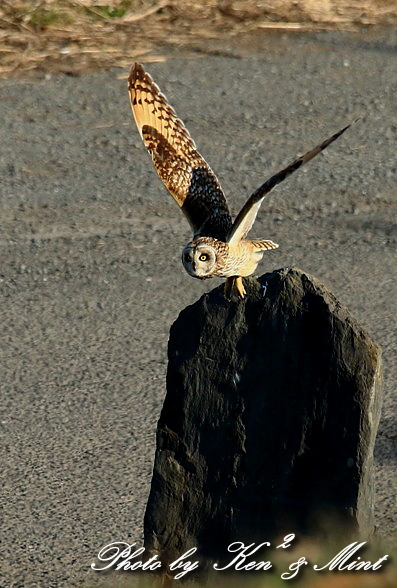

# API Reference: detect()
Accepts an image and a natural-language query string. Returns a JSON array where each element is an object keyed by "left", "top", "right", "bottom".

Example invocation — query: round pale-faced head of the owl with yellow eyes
[{"left": 182, "top": 237, "right": 227, "bottom": 280}]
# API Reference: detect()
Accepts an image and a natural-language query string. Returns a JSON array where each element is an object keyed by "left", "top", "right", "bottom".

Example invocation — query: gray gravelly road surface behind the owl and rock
[{"left": 0, "top": 31, "right": 397, "bottom": 587}]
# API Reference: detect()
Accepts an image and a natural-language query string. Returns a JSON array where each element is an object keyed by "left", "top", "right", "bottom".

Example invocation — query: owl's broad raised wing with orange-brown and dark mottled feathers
[{"left": 128, "top": 63, "right": 232, "bottom": 241}]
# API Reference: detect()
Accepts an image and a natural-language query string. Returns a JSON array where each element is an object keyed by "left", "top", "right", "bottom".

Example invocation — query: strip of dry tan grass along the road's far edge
[{"left": 0, "top": 0, "right": 397, "bottom": 78}]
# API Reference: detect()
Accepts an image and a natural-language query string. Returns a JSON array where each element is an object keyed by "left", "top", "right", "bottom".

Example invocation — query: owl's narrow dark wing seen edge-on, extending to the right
[{"left": 227, "top": 121, "right": 356, "bottom": 244}]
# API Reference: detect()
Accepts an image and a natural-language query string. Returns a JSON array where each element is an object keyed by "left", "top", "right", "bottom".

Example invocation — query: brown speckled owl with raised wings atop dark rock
[{"left": 128, "top": 63, "right": 351, "bottom": 299}]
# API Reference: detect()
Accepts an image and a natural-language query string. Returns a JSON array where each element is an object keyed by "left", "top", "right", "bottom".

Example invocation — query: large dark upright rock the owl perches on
[{"left": 145, "top": 269, "right": 381, "bottom": 560}]
